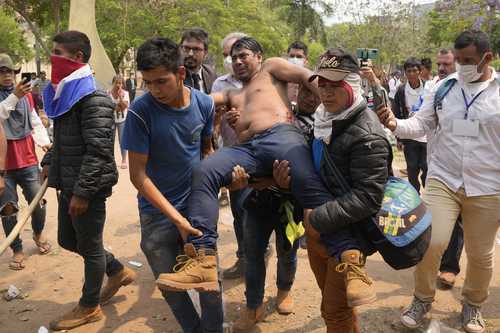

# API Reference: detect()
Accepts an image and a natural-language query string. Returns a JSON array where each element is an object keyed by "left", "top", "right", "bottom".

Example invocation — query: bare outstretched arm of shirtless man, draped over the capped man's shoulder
[{"left": 263, "top": 58, "right": 319, "bottom": 97}]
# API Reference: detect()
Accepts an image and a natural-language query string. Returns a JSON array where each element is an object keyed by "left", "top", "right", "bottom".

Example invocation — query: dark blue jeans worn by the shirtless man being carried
[{"left": 187, "top": 124, "right": 357, "bottom": 253}]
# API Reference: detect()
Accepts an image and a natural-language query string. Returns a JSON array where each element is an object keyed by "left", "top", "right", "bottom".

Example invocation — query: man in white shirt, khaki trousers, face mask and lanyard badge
[{"left": 378, "top": 30, "right": 500, "bottom": 333}]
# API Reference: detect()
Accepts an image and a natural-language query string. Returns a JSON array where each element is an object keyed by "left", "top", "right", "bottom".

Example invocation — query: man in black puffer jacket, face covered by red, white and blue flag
[{"left": 42, "top": 31, "right": 135, "bottom": 330}]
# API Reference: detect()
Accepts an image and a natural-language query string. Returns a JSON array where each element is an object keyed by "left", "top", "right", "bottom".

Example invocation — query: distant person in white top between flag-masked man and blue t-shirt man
[{"left": 109, "top": 75, "right": 130, "bottom": 169}]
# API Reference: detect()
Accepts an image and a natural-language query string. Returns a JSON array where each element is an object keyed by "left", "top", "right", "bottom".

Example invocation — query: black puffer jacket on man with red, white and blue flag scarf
[{"left": 42, "top": 91, "right": 118, "bottom": 200}]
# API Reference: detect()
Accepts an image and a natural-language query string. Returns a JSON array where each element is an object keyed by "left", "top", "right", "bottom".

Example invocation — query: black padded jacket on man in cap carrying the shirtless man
[{"left": 310, "top": 103, "right": 392, "bottom": 233}]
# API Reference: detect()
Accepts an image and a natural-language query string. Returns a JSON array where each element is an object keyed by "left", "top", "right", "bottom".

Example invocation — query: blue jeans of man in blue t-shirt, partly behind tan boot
[{"left": 140, "top": 213, "right": 224, "bottom": 333}]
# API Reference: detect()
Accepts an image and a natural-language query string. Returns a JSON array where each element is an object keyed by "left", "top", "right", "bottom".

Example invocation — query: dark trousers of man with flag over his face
[{"left": 57, "top": 193, "right": 123, "bottom": 307}]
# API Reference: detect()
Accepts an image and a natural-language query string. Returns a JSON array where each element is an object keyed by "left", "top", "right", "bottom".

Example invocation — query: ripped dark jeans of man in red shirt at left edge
[{"left": 0, "top": 165, "right": 45, "bottom": 252}]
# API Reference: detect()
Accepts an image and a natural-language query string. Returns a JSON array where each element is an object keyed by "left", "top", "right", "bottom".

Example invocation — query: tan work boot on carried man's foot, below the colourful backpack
[{"left": 335, "top": 250, "right": 376, "bottom": 307}]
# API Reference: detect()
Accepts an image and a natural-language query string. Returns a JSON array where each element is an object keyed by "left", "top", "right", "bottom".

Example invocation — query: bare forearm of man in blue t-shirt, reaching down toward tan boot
[{"left": 129, "top": 151, "right": 201, "bottom": 240}]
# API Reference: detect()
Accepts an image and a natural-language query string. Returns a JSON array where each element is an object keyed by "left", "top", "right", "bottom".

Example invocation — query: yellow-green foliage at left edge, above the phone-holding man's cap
[{"left": 0, "top": 8, "right": 33, "bottom": 63}]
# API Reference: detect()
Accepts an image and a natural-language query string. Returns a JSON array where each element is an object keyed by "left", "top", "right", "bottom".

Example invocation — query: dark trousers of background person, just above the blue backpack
[{"left": 403, "top": 140, "right": 427, "bottom": 193}]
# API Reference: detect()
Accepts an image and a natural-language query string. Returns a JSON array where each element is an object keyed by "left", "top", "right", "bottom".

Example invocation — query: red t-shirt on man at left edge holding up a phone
[{"left": 5, "top": 134, "right": 38, "bottom": 170}]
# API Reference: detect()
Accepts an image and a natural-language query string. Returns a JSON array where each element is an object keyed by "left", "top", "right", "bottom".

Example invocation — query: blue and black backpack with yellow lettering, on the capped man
[{"left": 323, "top": 142, "right": 432, "bottom": 270}]
